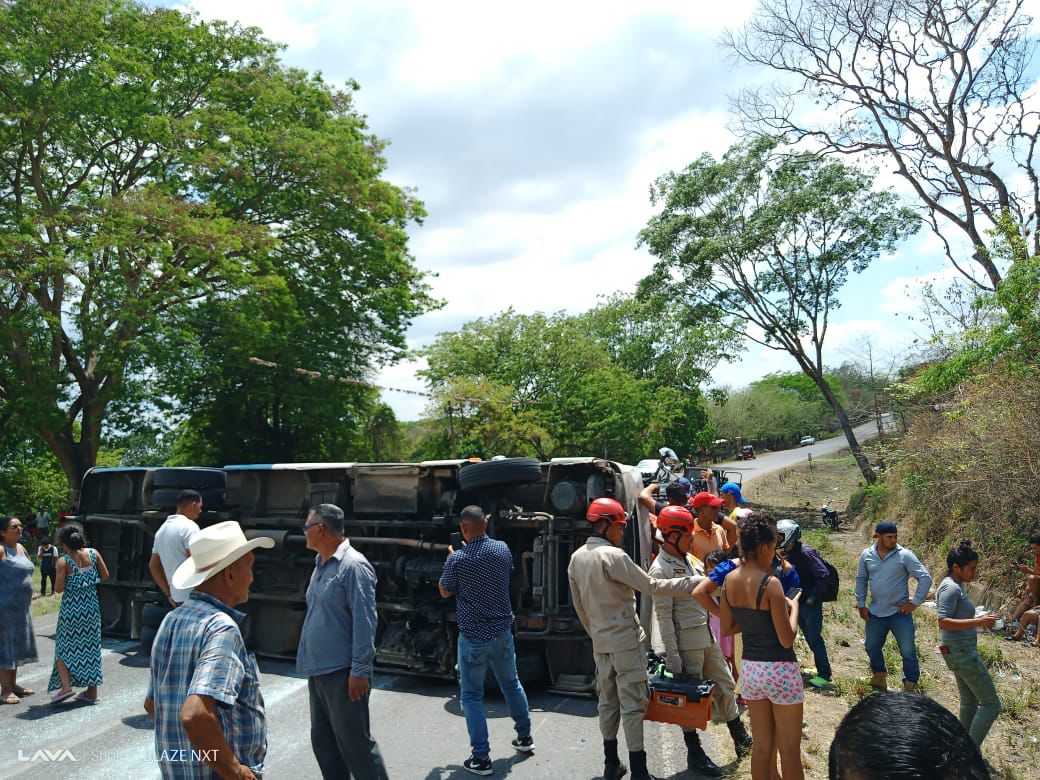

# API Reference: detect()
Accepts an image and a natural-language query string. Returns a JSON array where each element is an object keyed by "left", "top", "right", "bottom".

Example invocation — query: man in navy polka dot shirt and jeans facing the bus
[{"left": 440, "top": 505, "right": 535, "bottom": 775}]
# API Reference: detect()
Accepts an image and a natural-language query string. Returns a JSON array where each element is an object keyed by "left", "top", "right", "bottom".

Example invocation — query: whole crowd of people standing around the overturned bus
[{"left": 0, "top": 479, "right": 1027, "bottom": 780}]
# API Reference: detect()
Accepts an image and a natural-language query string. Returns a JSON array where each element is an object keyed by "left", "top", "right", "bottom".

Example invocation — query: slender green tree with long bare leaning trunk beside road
[{"left": 641, "top": 138, "right": 917, "bottom": 483}]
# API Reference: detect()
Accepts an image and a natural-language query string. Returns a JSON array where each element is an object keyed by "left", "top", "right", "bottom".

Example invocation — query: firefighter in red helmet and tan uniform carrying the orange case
[{"left": 650, "top": 506, "right": 751, "bottom": 777}]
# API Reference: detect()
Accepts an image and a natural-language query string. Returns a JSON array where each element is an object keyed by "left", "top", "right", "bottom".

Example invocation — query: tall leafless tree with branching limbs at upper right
[{"left": 725, "top": 0, "right": 1040, "bottom": 290}]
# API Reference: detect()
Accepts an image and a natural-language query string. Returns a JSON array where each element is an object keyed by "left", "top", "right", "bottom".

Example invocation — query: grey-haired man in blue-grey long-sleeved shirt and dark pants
[{"left": 296, "top": 503, "right": 387, "bottom": 780}]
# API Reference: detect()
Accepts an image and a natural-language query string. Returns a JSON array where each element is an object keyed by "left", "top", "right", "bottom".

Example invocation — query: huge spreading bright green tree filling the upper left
[{"left": 0, "top": 0, "right": 432, "bottom": 487}]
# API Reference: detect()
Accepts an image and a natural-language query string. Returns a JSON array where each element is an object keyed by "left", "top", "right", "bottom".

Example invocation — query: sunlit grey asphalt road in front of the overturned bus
[{"left": 0, "top": 615, "right": 734, "bottom": 780}]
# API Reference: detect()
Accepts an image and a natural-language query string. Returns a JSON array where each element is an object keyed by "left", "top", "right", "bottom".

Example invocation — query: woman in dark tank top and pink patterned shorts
[{"left": 720, "top": 512, "right": 805, "bottom": 780}]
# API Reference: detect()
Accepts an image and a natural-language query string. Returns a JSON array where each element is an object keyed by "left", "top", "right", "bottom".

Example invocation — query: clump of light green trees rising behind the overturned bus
[{"left": 423, "top": 298, "right": 706, "bottom": 462}]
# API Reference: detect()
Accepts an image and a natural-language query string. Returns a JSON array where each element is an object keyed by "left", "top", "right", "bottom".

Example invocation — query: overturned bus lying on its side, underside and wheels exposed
[{"left": 76, "top": 458, "right": 650, "bottom": 693}]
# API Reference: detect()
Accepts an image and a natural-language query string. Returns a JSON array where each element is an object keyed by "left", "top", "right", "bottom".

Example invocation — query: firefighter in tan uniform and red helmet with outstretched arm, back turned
[{"left": 567, "top": 498, "right": 697, "bottom": 780}]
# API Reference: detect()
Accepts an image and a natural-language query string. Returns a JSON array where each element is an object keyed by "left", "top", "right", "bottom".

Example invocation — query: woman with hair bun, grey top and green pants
[{"left": 935, "top": 539, "right": 1000, "bottom": 746}]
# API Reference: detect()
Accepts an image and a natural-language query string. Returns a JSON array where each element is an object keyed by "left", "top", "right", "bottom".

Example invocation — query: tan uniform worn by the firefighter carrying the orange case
[{"left": 650, "top": 548, "right": 739, "bottom": 731}]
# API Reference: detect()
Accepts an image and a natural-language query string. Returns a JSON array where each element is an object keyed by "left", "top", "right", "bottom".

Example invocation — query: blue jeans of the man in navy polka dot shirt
[{"left": 459, "top": 629, "right": 530, "bottom": 757}]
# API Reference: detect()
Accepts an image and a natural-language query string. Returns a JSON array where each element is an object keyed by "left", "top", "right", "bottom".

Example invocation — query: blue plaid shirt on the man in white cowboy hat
[{"left": 148, "top": 591, "right": 267, "bottom": 780}]
